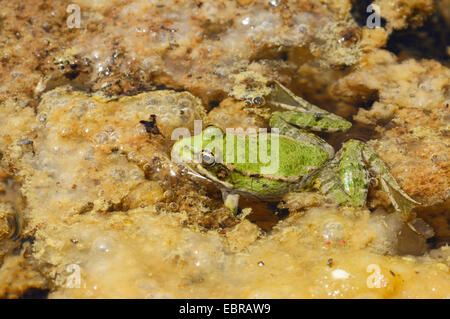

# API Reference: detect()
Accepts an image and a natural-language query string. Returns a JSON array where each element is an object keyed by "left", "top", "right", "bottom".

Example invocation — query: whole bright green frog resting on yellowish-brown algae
[{"left": 171, "top": 74, "right": 419, "bottom": 216}]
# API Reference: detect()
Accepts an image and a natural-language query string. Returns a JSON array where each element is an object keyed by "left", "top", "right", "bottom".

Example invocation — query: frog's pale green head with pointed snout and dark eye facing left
[{"left": 171, "top": 126, "right": 224, "bottom": 174}]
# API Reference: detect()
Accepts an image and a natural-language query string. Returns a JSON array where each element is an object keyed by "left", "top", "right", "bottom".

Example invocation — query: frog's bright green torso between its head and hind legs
[{"left": 220, "top": 135, "right": 329, "bottom": 199}]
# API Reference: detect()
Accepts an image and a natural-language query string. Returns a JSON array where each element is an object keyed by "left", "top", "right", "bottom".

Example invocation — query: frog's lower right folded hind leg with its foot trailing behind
[{"left": 315, "top": 140, "right": 420, "bottom": 217}]
